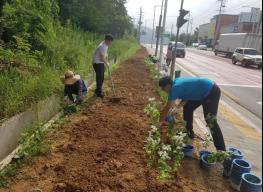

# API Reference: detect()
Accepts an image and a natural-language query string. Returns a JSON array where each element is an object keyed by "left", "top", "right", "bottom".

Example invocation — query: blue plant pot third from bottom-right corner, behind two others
[{"left": 223, "top": 147, "right": 244, "bottom": 179}]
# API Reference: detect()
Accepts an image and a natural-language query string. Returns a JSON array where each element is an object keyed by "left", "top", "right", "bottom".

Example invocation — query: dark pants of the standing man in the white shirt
[{"left": 93, "top": 63, "right": 105, "bottom": 96}]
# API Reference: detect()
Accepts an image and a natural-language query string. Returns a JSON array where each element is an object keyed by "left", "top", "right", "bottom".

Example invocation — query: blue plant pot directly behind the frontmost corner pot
[{"left": 231, "top": 159, "right": 252, "bottom": 191}]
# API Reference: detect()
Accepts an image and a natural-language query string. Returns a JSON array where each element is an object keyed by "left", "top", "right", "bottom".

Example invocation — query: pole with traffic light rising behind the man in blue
[{"left": 170, "top": 0, "right": 189, "bottom": 79}]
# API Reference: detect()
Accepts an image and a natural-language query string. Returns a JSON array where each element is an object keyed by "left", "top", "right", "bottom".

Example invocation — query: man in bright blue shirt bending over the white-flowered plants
[{"left": 159, "top": 77, "right": 226, "bottom": 151}]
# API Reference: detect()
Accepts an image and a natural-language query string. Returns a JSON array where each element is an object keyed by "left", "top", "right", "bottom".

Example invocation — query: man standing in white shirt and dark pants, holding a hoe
[{"left": 92, "top": 34, "right": 114, "bottom": 98}]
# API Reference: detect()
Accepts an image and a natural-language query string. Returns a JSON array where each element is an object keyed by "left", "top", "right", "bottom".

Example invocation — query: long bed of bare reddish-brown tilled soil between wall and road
[{"left": 0, "top": 49, "right": 235, "bottom": 192}]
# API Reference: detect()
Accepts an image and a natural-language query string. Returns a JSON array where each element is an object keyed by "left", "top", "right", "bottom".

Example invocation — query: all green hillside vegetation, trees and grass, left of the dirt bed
[{"left": 0, "top": 0, "right": 139, "bottom": 120}]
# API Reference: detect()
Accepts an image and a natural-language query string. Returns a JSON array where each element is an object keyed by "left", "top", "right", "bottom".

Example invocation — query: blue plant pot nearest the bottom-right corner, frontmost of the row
[{"left": 240, "top": 173, "right": 262, "bottom": 192}]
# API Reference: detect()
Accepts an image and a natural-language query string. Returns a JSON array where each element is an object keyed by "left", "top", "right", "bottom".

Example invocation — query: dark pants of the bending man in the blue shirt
[{"left": 184, "top": 85, "right": 226, "bottom": 151}]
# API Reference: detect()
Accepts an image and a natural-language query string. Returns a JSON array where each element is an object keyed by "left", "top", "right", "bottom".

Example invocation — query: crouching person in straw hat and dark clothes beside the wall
[{"left": 60, "top": 71, "right": 88, "bottom": 104}]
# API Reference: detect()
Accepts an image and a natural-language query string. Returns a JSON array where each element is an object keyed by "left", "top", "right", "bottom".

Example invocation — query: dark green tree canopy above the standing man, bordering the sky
[{"left": 58, "top": 0, "right": 133, "bottom": 36}]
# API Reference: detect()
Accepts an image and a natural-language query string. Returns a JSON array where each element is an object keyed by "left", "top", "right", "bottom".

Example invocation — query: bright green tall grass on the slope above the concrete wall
[{"left": 0, "top": 26, "right": 139, "bottom": 121}]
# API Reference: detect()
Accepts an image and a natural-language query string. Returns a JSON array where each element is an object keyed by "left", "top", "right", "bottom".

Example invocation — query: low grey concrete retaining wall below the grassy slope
[{"left": 0, "top": 74, "right": 94, "bottom": 162}]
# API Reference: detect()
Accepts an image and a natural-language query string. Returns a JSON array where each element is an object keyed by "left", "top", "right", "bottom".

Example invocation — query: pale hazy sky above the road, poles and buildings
[{"left": 126, "top": 0, "right": 262, "bottom": 31}]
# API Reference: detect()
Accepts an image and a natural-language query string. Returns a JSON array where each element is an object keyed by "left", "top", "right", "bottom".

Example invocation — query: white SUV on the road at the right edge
[{"left": 232, "top": 48, "right": 262, "bottom": 68}]
